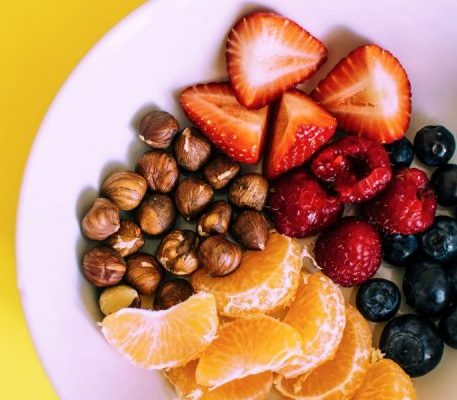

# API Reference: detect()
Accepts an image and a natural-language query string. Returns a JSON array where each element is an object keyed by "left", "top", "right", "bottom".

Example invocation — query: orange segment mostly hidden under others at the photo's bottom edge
[{"left": 164, "top": 360, "right": 273, "bottom": 400}]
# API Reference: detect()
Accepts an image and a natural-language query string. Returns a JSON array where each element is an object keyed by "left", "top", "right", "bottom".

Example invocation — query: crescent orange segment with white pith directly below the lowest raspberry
[{"left": 279, "top": 272, "right": 346, "bottom": 378}]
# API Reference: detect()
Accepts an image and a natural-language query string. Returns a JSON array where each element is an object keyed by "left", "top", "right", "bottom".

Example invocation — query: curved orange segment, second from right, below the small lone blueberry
[{"left": 275, "top": 306, "right": 371, "bottom": 400}]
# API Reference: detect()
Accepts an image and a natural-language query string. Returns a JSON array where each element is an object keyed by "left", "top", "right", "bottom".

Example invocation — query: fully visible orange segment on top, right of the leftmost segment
[{"left": 196, "top": 315, "right": 302, "bottom": 388}]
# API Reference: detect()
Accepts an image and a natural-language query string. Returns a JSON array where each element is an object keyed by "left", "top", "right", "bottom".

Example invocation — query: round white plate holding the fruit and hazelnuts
[{"left": 17, "top": 0, "right": 457, "bottom": 400}]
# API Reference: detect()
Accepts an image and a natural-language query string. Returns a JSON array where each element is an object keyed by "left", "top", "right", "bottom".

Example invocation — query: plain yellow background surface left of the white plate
[{"left": 0, "top": 0, "right": 143, "bottom": 400}]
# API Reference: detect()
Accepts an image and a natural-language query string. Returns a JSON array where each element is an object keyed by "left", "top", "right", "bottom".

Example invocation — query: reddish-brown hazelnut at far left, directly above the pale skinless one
[{"left": 83, "top": 246, "right": 126, "bottom": 287}]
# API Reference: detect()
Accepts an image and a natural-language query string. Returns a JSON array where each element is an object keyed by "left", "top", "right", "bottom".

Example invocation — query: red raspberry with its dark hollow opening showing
[{"left": 311, "top": 136, "right": 392, "bottom": 203}]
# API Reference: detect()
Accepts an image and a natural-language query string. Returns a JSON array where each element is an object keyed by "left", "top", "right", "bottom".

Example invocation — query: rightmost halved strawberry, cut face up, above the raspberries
[{"left": 311, "top": 45, "right": 411, "bottom": 143}]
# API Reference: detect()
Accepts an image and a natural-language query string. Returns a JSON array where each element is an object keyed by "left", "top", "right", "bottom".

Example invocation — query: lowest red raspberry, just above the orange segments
[{"left": 315, "top": 217, "right": 381, "bottom": 286}]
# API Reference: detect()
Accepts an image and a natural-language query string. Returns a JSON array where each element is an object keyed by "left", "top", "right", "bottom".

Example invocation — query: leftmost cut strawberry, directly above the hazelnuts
[{"left": 181, "top": 83, "right": 268, "bottom": 164}]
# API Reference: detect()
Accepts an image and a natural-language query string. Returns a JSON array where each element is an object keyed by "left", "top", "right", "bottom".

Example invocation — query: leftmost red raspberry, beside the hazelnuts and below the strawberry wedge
[{"left": 269, "top": 170, "right": 343, "bottom": 237}]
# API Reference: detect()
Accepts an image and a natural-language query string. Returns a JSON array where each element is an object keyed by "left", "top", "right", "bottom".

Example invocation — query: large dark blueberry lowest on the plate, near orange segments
[{"left": 379, "top": 314, "right": 444, "bottom": 378}]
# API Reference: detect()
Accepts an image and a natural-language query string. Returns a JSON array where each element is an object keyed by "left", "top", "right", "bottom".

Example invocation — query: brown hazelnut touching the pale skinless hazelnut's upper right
[{"left": 126, "top": 253, "right": 162, "bottom": 296}]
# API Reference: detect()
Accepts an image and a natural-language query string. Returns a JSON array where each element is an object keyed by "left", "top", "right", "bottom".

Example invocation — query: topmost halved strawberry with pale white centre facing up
[{"left": 226, "top": 12, "right": 327, "bottom": 108}]
